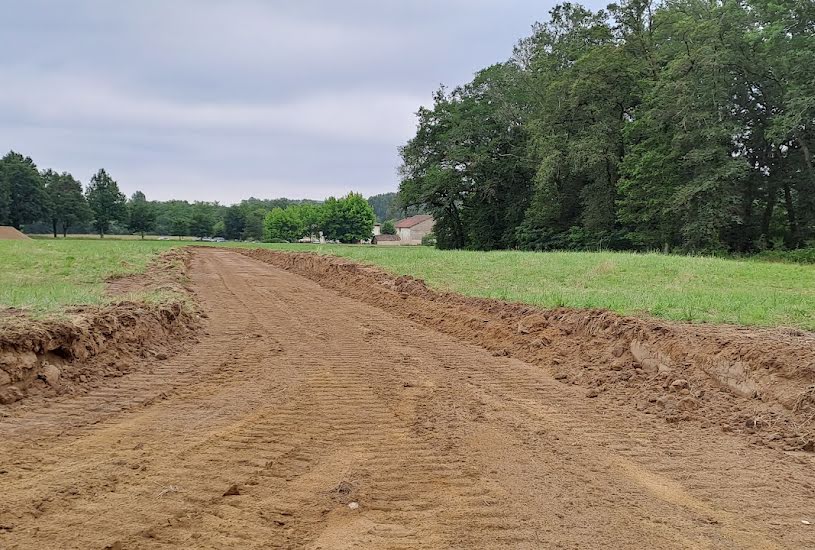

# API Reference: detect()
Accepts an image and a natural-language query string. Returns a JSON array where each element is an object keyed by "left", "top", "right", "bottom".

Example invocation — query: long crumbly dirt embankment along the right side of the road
[{"left": 240, "top": 250, "right": 815, "bottom": 451}]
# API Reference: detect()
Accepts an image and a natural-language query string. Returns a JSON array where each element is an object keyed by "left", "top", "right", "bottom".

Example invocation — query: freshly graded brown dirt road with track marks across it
[{"left": 0, "top": 249, "right": 815, "bottom": 549}]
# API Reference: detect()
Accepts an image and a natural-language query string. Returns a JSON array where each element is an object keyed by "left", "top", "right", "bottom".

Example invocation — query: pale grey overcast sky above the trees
[{"left": 0, "top": 0, "right": 605, "bottom": 204}]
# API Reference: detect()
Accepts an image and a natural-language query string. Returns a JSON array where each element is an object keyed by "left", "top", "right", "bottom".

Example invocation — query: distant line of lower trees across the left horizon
[{"left": 0, "top": 151, "right": 402, "bottom": 242}]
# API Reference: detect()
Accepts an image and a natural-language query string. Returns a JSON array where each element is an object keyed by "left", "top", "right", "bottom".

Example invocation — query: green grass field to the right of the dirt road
[{"left": 255, "top": 245, "right": 815, "bottom": 330}]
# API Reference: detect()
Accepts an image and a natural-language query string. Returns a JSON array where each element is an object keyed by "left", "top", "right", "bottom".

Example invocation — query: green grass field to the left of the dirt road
[{"left": 0, "top": 239, "right": 180, "bottom": 316}]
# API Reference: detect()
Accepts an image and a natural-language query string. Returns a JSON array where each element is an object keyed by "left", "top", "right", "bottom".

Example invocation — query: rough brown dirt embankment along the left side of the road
[{"left": 0, "top": 249, "right": 199, "bottom": 405}]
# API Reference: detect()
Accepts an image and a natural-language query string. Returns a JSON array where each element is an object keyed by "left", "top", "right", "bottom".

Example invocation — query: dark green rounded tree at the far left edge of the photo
[{"left": 0, "top": 151, "right": 48, "bottom": 229}]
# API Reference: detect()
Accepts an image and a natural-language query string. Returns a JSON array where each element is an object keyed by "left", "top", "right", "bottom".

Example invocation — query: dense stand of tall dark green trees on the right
[{"left": 399, "top": 0, "right": 815, "bottom": 252}]
